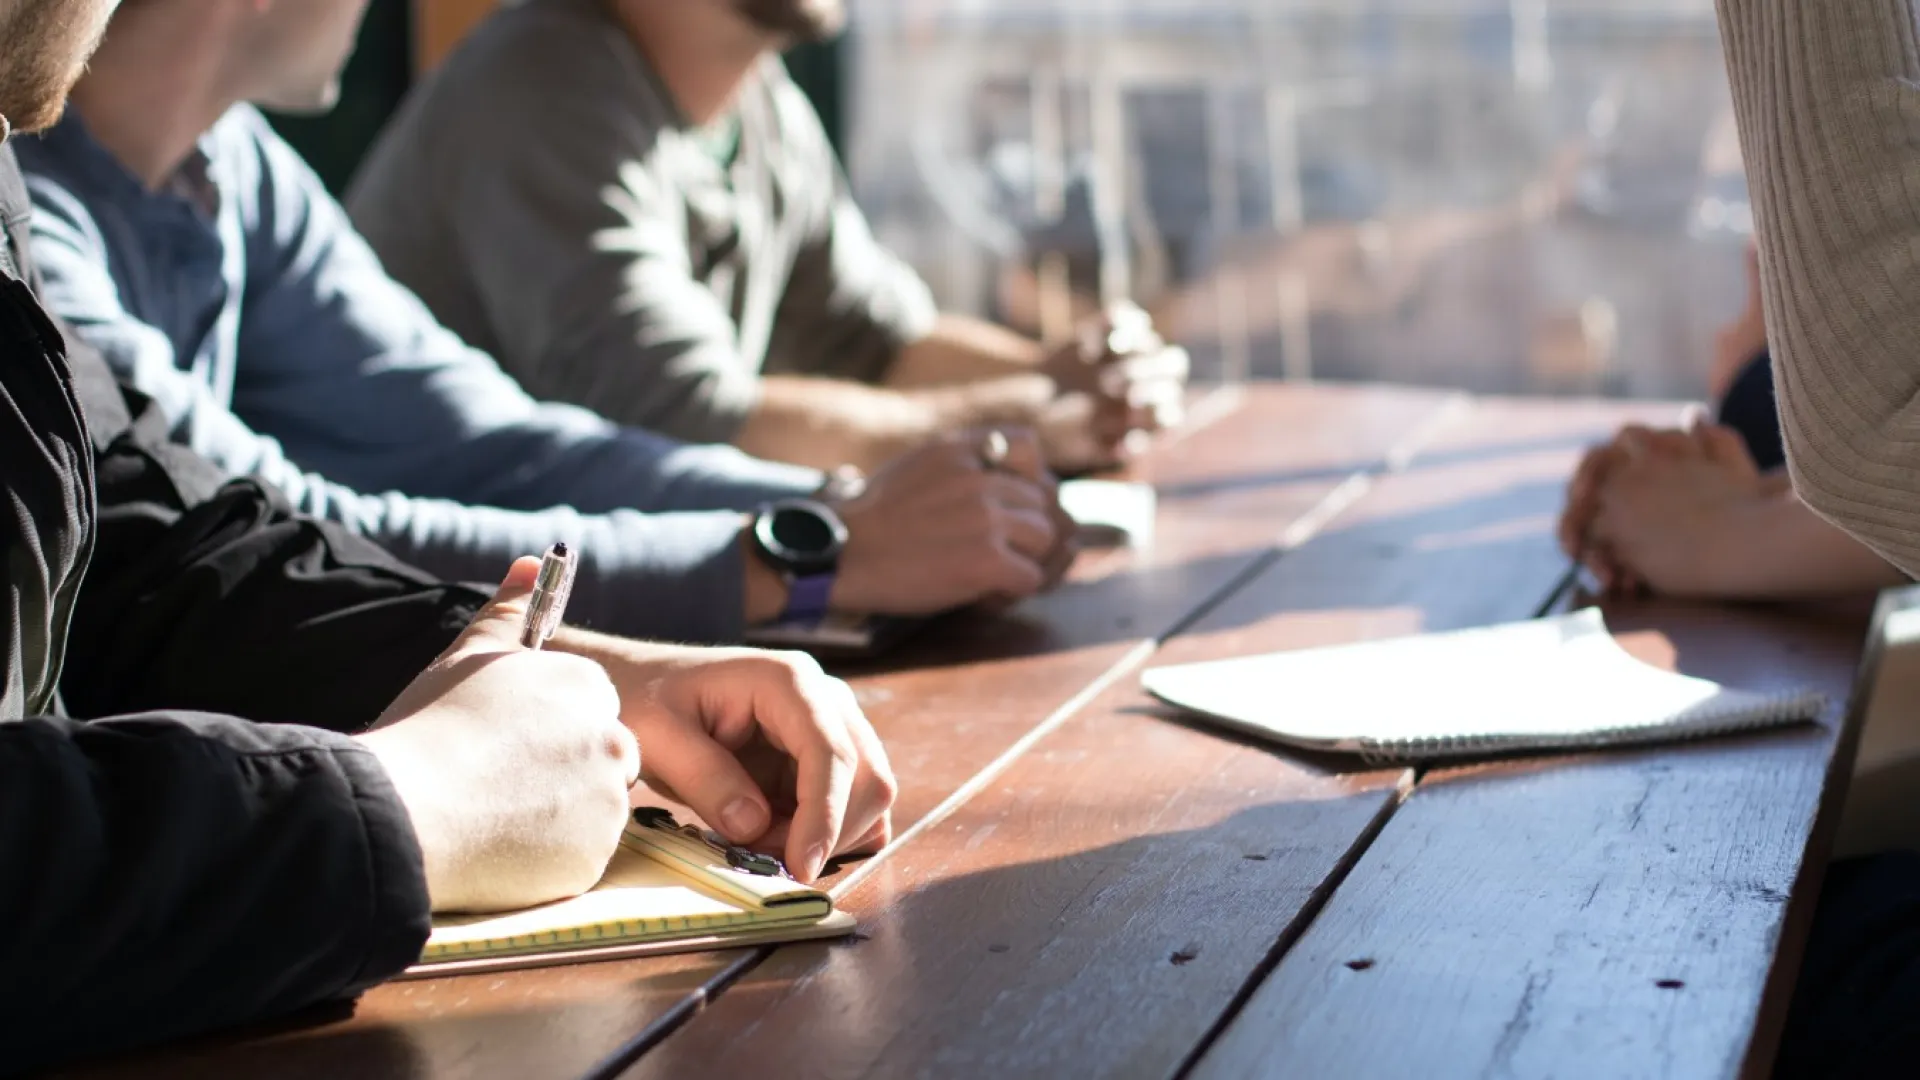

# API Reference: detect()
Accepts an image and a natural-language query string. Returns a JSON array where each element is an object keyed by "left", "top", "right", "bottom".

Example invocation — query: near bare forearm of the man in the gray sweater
[{"left": 735, "top": 373, "right": 1052, "bottom": 471}]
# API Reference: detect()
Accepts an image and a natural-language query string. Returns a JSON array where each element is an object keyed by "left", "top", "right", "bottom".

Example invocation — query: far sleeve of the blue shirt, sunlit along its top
[{"left": 234, "top": 115, "right": 820, "bottom": 513}]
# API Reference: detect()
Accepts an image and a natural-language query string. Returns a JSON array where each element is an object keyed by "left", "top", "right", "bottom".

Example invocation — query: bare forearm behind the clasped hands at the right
[{"left": 1713, "top": 492, "right": 1907, "bottom": 600}]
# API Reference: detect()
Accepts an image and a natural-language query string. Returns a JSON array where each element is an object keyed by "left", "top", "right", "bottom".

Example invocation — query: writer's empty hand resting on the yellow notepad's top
[{"left": 563, "top": 638, "right": 899, "bottom": 880}]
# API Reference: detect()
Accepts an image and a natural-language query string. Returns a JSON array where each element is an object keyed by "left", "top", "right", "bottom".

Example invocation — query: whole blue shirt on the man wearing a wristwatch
[{"left": 17, "top": 106, "right": 820, "bottom": 640}]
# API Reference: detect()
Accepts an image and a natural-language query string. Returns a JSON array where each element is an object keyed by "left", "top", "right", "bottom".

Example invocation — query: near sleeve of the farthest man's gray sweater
[{"left": 348, "top": 6, "right": 760, "bottom": 444}]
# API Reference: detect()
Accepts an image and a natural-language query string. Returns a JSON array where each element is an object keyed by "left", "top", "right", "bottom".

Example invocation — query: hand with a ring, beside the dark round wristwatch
[{"left": 829, "top": 430, "right": 1073, "bottom": 615}]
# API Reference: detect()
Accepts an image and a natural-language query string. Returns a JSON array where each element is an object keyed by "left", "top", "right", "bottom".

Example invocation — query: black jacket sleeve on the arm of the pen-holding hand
[{"left": 0, "top": 713, "right": 428, "bottom": 1072}]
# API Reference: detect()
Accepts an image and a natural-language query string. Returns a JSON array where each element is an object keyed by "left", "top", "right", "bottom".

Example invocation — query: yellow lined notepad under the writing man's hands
[{"left": 407, "top": 807, "right": 854, "bottom": 976}]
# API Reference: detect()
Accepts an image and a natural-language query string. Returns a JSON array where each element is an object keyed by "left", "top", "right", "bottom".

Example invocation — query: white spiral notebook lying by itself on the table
[{"left": 1140, "top": 607, "right": 1826, "bottom": 763}]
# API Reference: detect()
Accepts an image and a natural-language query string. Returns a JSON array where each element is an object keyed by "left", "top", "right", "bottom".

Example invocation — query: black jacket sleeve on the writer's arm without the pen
[{"left": 60, "top": 344, "right": 487, "bottom": 732}]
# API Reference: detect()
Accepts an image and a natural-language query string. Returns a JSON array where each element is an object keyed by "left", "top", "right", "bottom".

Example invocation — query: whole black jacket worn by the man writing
[{"left": 0, "top": 146, "right": 439, "bottom": 1072}]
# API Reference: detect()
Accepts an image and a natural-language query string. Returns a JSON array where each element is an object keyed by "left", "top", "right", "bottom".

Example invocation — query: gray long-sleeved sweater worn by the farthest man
[{"left": 348, "top": 4, "right": 937, "bottom": 442}]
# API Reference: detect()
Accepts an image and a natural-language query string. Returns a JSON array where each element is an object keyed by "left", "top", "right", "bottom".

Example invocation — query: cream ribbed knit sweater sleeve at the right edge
[{"left": 1718, "top": 0, "right": 1920, "bottom": 575}]
